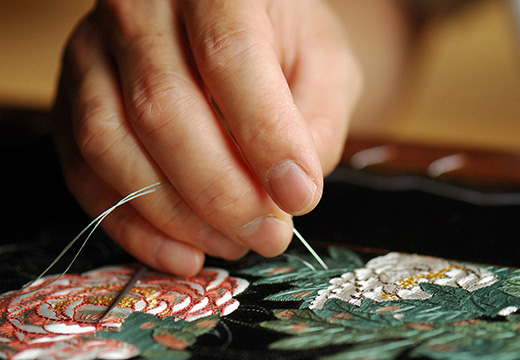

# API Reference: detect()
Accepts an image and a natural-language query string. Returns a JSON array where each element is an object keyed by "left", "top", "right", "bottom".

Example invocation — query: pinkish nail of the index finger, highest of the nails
[{"left": 267, "top": 160, "right": 318, "bottom": 215}]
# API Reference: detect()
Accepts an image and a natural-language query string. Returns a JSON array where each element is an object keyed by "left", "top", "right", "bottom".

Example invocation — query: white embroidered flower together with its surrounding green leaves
[{"left": 245, "top": 250, "right": 520, "bottom": 360}]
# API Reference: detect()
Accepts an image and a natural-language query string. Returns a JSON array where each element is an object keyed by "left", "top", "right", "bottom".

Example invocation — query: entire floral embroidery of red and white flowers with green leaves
[{"left": 0, "top": 248, "right": 520, "bottom": 360}]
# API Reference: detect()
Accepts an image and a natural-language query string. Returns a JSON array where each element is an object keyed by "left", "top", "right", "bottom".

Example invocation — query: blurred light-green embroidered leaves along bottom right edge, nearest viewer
[{"left": 262, "top": 310, "right": 520, "bottom": 360}]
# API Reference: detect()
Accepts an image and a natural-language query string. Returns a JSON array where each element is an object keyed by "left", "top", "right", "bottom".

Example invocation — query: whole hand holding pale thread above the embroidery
[{"left": 51, "top": 0, "right": 360, "bottom": 276}]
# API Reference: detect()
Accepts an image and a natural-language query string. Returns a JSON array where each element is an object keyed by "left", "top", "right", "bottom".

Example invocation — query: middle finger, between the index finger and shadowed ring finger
[{"left": 100, "top": 1, "right": 292, "bottom": 257}]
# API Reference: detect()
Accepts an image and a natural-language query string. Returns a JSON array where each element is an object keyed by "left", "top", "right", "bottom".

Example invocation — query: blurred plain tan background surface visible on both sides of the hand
[{"left": 0, "top": 0, "right": 520, "bottom": 152}]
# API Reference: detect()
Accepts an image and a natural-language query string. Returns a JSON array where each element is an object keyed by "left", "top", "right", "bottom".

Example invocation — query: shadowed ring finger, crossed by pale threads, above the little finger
[{"left": 55, "top": 10, "right": 253, "bottom": 264}]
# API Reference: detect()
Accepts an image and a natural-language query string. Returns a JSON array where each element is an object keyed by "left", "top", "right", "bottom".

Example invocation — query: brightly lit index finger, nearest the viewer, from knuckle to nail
[{"left": 183, "top": 1, "right": 323, "bottom": 215}]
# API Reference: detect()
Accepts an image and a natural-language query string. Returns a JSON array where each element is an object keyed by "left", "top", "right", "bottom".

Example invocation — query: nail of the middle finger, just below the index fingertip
[{"left": 236, "top": 216, "right": 292, "bottom": 256}]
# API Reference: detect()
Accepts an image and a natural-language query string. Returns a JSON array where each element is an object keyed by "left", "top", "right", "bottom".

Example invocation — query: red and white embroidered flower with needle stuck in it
[{"left": 0, "top": 265, "right": 249, "bottom": 359}]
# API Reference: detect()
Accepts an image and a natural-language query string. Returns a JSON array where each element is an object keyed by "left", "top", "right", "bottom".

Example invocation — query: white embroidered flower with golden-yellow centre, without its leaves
[{"left": 309, "top": 253, "right": 497, "bottom": 309}]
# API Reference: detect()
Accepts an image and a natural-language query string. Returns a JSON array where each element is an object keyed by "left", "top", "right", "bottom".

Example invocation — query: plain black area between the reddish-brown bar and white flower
[{"left": 295, "top": 168, "right": 520, "bottom": 267}]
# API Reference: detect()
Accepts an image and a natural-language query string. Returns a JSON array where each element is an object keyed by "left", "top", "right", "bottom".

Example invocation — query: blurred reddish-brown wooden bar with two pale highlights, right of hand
[{"left": 342, "top": 136, "right": 520, "bottom": 191}]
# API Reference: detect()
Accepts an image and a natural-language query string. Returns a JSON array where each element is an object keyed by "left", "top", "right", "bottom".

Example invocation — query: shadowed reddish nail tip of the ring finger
[{"left": 199, "top": 224, "right": 248, "bottom": 260}]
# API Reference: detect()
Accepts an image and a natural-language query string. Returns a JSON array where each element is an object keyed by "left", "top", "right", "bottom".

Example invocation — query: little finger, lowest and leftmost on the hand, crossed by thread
[{"left": 53, "top": 128, "right": 204, "bottom": 276}]
